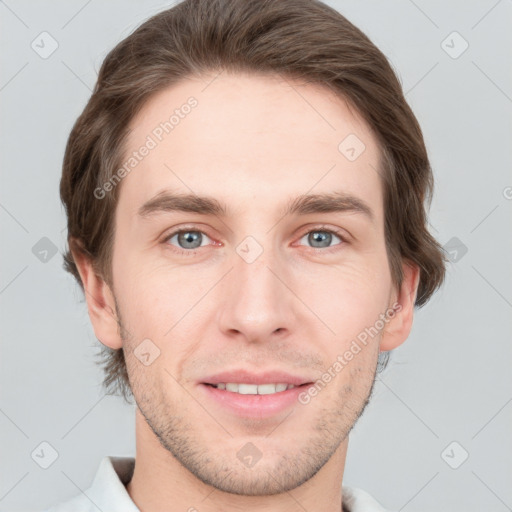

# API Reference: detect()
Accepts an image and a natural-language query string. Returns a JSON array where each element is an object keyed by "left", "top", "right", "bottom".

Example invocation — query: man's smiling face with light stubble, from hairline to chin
[{"left": 109, "top": 72, "right": 404, "bottom": 495}]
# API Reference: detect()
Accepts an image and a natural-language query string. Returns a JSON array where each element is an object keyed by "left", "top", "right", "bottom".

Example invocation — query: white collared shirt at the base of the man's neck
[{"left": 43, "top": 456, "right": 394, "bottom": 512}]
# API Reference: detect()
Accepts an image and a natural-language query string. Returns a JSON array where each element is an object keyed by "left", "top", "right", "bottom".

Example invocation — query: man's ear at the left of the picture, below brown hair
[{"left": 73, "top": 246, "right": 123, "bottom": 349}]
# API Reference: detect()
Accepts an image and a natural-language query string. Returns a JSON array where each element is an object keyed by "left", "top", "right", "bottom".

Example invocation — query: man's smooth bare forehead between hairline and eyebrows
[{"left": 120, "top": 72, "right": 382, "bottom": 222}]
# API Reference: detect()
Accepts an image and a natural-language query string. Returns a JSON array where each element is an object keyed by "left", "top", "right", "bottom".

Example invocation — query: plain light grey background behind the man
[{"left": 0, "top": 0, "right": 512, "bottom": 512}]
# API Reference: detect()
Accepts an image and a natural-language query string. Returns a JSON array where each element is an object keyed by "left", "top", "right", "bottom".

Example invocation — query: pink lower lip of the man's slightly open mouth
[{"left": 199, "top": 383, "right": 312, "bottom": 418}]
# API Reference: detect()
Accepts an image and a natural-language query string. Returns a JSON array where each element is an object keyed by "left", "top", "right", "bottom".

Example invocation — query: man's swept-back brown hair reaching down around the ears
[{"left": 60, "top": 0, "right": 446, "bottom": 404}]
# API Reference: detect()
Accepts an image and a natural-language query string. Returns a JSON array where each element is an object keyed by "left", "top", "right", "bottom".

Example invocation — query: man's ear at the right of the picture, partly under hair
[{"left": 380, "top": 262, "right": 420, "bottom": 352}]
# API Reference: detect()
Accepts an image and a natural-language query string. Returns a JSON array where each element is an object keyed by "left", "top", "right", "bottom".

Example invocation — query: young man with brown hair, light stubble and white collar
[{"left": 51, "top": 0, "right": 445, "bottom": 512}]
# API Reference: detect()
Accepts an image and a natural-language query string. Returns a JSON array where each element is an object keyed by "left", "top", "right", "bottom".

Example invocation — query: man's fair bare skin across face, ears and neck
[{"left": 76, "top": 72, "right": 419, "bottom": 512}]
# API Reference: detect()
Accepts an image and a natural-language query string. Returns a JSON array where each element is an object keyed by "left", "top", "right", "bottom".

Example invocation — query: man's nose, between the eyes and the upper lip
[{"left": 219, "top": 244, "right": 298, "bottom": 343}]
